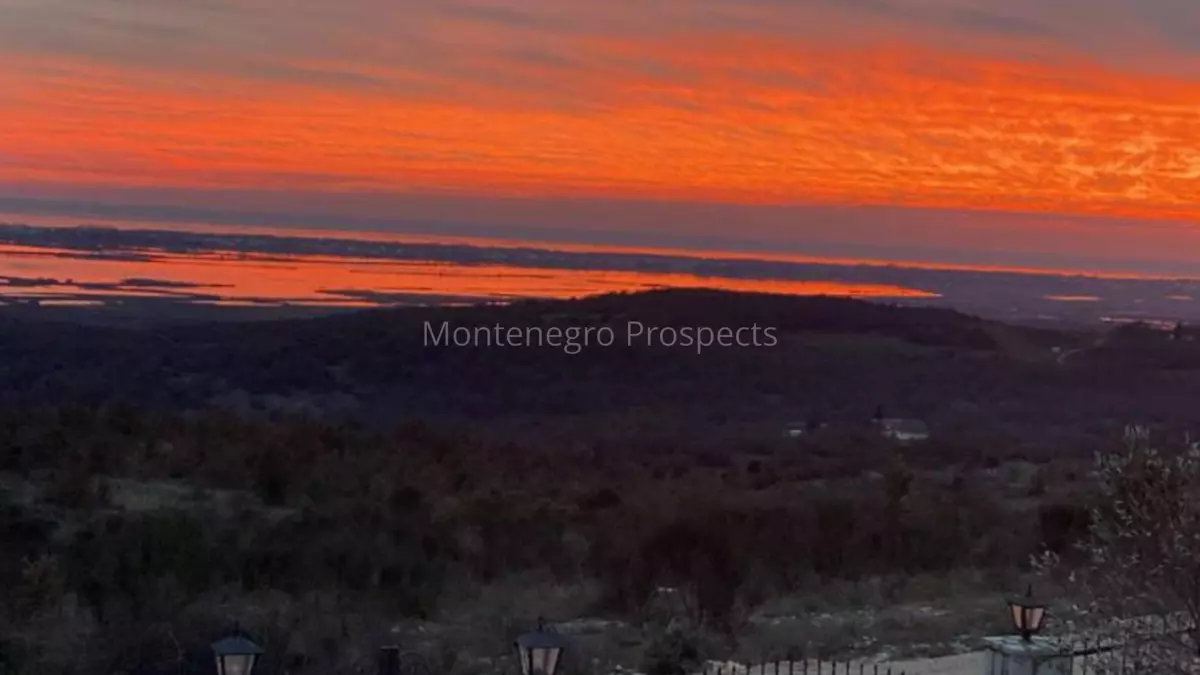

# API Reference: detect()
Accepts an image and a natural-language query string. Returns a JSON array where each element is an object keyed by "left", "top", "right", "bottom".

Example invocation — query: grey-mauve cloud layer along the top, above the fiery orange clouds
[{"left": 7, "top": 0, "right": 1200, "bottom": 85}]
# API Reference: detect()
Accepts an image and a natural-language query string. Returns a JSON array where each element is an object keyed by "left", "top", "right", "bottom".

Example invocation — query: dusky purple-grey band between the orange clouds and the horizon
[{"left": 0, "top": 190, "right": 1200, "bottom": 275}]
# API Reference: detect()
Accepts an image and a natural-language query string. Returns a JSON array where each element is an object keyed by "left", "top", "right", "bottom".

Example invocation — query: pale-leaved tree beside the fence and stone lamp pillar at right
[{"left": 1037, "top": 430, "right": 1200, "bottom": 674}]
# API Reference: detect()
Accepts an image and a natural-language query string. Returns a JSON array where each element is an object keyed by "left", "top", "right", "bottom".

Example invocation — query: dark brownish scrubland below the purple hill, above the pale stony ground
[{"left": 0, "top": 407, "right": 1104, "bottom": 673}]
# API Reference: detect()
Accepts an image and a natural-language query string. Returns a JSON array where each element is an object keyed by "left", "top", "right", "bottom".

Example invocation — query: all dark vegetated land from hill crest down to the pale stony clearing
[{"left": 0, "top": 292, "right": 1200, "bottom": 675}]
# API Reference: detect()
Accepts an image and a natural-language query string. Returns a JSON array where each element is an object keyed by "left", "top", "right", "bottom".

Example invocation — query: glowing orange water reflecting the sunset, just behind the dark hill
[{"left": 0, "top": 244, "right": 940, "bottom": 306}]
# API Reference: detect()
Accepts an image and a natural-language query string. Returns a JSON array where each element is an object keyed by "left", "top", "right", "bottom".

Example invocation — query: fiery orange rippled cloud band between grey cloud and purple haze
[{"left": 7, "top": 35, "right": 1200, "bottom": 219}]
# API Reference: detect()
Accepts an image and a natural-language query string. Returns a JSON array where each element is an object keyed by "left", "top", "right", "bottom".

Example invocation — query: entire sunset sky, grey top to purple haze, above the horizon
[{"left": 0, "top": 0, "right": 1200, "bottom": 274}]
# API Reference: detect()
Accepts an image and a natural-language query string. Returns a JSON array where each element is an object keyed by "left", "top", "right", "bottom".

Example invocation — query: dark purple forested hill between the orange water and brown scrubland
[{"left": 0, "top": 285, "right": 1200, "bottom": 449}]
